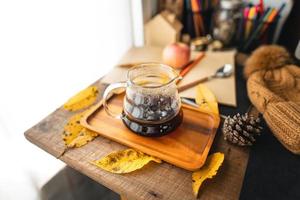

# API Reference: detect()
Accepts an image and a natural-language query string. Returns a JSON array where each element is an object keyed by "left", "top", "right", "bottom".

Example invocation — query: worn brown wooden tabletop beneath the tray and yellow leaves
[{"left": 25, "top": 81, "right": 248, "bottom": 200}]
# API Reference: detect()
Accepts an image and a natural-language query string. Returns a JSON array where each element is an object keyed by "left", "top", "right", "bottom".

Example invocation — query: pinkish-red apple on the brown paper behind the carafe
[{"left": 162, "top": 43, "right": 191, "bottom": 69}]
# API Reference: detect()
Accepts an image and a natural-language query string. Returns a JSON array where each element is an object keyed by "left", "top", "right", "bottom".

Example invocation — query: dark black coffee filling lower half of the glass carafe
[{"left": 122, "top": 95, "right": 183, "bottom": 136}]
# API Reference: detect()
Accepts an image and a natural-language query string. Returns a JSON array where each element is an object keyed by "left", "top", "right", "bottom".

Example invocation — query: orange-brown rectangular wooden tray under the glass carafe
[{"left": 81, "top": 95, "right": 220, "bottom": 171}]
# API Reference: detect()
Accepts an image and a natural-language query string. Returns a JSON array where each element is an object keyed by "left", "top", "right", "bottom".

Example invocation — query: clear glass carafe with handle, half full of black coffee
[{"left": 103, "top": 63, "right": 183, "bottom": 136}]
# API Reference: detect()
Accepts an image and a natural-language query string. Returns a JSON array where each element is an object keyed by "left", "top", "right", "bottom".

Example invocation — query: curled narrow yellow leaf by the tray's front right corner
[{"left": 192, "top": 153, "right": 224, "bottom": 197}]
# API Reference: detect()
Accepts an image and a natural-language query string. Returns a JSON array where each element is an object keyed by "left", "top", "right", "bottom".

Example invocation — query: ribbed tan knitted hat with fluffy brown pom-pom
[{"left": 246, "top": 46, "right": 300, "bottom": 154}]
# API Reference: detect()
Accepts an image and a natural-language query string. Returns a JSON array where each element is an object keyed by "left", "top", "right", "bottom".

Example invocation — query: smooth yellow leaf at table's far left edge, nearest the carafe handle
[{"left": 64, "top": 86, "right": 98, "bottom": 111}]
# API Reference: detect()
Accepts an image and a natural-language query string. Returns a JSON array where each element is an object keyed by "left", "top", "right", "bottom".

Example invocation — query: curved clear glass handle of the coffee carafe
[{"left": 102, "top": 82, "right": 127, "bottom": 119}]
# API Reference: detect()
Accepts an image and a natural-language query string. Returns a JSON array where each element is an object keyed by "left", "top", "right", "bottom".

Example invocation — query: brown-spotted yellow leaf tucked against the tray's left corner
[{"left": 63, "top": 112, "right": 98, "bottom": 148}]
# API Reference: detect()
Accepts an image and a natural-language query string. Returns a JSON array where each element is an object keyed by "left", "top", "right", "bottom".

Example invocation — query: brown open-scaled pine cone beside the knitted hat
[{"left": 222, "top": 113, "right": 262, "bottom": 146}]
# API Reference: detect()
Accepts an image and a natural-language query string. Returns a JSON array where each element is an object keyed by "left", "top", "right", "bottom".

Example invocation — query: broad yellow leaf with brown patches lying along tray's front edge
[{"left": 92, "top": 149, "right": 161, "bottom": 174}]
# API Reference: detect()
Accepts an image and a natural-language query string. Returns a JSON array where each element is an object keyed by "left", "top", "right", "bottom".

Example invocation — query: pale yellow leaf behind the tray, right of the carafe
[{"left": 196, "top": 84, "right": 219, "bottom": 114}]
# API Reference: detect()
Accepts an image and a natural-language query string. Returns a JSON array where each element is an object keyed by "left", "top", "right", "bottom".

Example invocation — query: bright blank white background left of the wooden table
[{"left": 0, "top": 0, "right": 133, "bottom": 199}]
